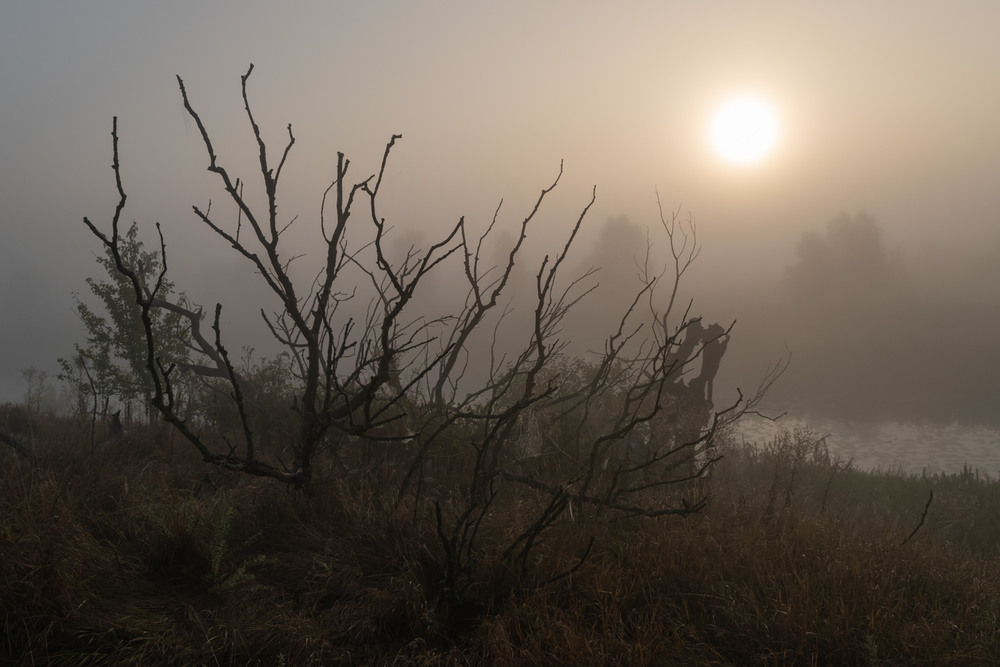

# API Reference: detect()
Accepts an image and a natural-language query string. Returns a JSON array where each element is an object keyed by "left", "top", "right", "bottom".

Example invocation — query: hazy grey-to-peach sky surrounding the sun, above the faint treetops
[{"left": 0, "top": 0, "right": 1000, "bottom": 400}]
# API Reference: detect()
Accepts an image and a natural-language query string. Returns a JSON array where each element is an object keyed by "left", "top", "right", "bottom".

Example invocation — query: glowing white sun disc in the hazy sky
[{"left": 711, "top": 97, "right": 778, "bottom": 164}]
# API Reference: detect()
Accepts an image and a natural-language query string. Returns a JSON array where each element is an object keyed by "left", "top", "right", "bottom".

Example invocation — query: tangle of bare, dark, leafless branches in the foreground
[{"left": 84, "top": 65, "right": 777, "bottom": 597}]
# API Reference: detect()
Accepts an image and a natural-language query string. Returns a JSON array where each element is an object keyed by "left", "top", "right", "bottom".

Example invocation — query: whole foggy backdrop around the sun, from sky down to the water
[{"left": 0, "top": 1, "right": 1000, "bottom": 434}]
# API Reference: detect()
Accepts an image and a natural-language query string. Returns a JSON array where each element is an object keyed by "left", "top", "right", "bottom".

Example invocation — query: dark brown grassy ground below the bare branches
[{"left": 0, "top": 420, "right": 1000, "bottom": 665}]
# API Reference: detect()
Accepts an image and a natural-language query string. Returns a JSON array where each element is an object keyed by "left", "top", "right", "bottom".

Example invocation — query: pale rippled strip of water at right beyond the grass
[{"left": 737, "top": 414, "right": 1000, "bottom": 478}]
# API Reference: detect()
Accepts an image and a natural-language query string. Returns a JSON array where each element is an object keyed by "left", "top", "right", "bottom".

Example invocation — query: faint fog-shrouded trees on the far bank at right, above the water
[{"left": 757, "top": 213, "right": 1000, "bottom": 423}]
